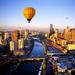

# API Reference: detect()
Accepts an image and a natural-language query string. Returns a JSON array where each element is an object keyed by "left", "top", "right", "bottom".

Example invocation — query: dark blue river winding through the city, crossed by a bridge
[{"left": 0, "top": 41, "right": 44, "bottom": 75}]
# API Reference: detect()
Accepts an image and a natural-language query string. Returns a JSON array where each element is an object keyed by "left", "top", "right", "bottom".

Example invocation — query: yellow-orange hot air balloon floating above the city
[{"left": 23, "top": 7, "right": 35, "bottom": 23}]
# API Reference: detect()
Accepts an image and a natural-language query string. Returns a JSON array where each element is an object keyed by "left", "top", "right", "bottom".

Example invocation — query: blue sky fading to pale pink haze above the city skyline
[{"left": 0, "top": 0, "right": 75, "bottom": 30}]
